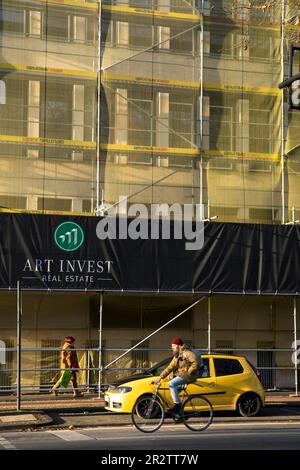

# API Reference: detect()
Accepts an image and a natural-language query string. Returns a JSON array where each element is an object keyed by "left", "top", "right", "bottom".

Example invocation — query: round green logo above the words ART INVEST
[{"left": 54, "top": 222, "right": 84, "bottom": 251}]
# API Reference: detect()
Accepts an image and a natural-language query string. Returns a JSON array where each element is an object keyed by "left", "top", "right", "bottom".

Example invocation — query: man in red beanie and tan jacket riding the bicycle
[{"left": 153, "top": 336, "right": 199, "bottom": 416}]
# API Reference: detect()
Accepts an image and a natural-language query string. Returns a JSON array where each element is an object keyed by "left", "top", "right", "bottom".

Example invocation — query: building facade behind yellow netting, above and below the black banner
[{"left": 0, "top": 0, "right": 300, "bottom": 388}]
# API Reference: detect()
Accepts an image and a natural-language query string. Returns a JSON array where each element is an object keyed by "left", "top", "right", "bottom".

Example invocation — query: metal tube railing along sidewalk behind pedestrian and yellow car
[{"left": 0, "top": 347, "right": 295, "bottom": 400}]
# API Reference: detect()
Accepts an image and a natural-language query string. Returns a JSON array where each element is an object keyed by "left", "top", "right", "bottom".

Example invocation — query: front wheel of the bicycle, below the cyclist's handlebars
[{"left": 131, "top": 397, "right": 165, "bottom": 432}]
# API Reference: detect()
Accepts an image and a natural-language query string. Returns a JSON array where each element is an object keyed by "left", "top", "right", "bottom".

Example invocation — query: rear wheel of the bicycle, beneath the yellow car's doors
[{"left": 182, "top": 395, "right": 214, "bottom": 431}]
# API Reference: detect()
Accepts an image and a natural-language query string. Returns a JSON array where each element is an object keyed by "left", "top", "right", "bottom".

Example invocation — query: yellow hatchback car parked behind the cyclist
[{"left": 105, "top": 354, "right": 265, "bottom": 417}]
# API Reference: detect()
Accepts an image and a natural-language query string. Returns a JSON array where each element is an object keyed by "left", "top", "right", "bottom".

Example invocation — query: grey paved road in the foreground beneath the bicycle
[{"left": 0, "top": 421, "right": 300, "bottom": 451}]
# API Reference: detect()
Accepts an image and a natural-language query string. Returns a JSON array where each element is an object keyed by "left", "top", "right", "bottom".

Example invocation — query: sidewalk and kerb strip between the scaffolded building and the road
[{"left": 0, "top": 392, "right": 300, "bottom": 432}]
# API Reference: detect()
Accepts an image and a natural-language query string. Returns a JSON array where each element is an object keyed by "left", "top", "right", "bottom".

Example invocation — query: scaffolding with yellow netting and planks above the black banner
[{"left": 0, "top": 0, "right": 299, "bottom": 223}]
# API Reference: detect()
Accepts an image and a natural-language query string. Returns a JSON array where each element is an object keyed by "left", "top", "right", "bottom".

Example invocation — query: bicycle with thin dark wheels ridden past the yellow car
[{"left": 131, "top": 382, "right": 213, "bottom": 433}]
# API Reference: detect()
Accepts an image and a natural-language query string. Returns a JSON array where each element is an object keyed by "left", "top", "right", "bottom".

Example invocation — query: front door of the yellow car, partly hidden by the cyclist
[{"left": 162, "top": 356, "right": 216, "bottom": 405}]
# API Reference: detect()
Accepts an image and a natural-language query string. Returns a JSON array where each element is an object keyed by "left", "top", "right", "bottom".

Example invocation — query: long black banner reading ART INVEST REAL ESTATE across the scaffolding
[{"left": 0, "top": 214, "right": 300, "bottom": 294}]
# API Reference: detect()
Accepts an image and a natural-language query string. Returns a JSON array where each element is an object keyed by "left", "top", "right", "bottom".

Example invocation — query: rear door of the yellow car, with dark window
[{"left": 213, "top": 357, "right": 245, "bottom": 409}]
